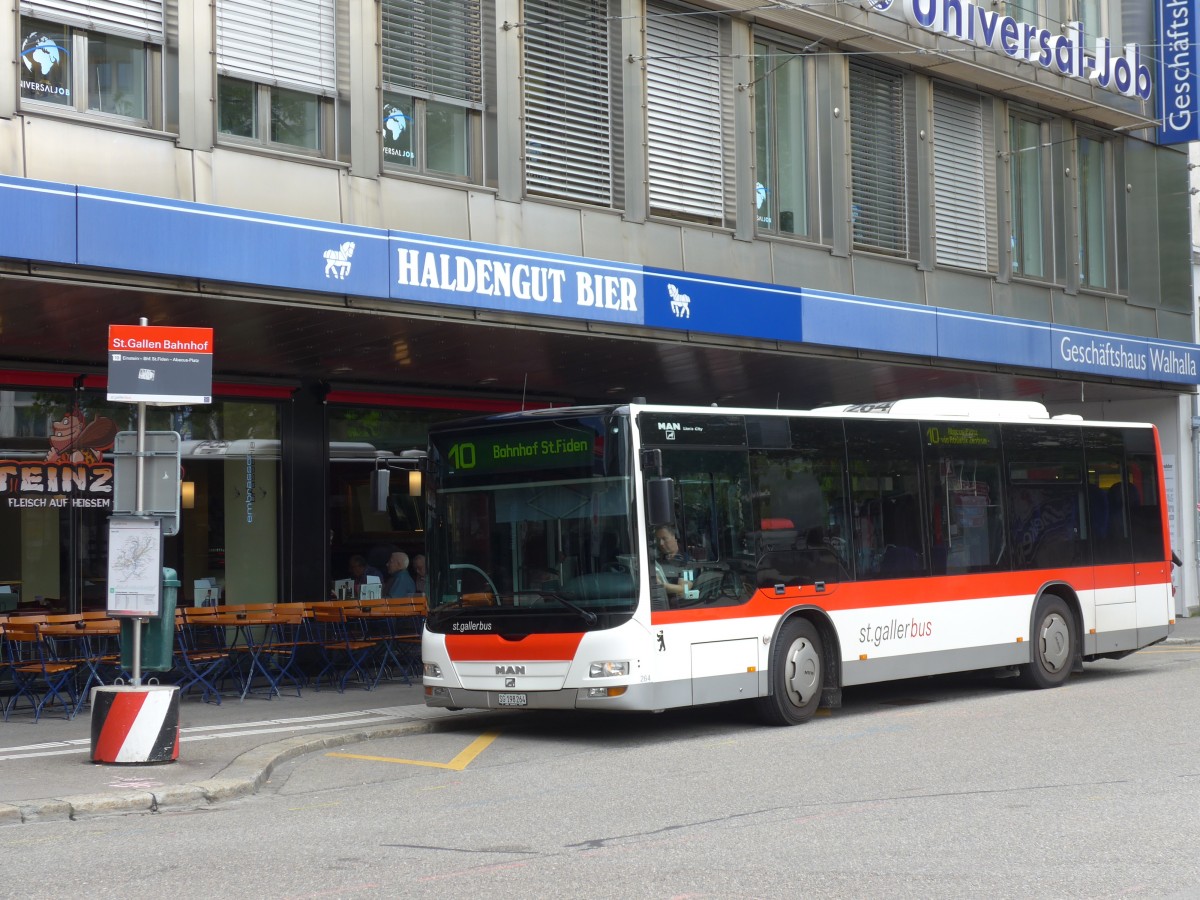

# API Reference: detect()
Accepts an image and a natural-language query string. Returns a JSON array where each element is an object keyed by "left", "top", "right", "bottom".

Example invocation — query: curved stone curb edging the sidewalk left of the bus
[{"left": 0, "top": 713, "right": 499, "bottom": 826}]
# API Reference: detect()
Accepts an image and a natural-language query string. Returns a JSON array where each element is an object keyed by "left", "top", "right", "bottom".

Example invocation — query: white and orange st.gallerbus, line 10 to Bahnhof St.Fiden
[{"left": 421, "top": 398, "right": 1174, "bottom": 725}]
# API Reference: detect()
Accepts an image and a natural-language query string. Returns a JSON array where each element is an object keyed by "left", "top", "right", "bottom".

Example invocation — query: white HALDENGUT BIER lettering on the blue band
[{"left": 396, "top": 247, "right": 638, "bottom": 313}]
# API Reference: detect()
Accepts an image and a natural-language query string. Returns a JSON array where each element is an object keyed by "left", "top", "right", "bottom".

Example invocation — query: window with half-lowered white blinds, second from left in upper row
[{"left": 217, "top": 0, "right": 336, "bottom": 155}]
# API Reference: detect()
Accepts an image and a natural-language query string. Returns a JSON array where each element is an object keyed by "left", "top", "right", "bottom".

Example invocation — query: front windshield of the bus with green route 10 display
[{"left": 428, "top": 412, "right": 637, "bottom": 634}]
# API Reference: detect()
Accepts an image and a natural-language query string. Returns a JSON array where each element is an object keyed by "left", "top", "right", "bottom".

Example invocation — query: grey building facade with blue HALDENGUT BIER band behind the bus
[{"left": 0, "top": 0, "right": 1200, "bottom": 612}]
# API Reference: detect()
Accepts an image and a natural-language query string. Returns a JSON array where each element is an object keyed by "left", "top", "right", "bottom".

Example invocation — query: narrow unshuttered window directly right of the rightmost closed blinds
[{"left": 1008, "top": 115, "right": 1050, "bottom": 278}]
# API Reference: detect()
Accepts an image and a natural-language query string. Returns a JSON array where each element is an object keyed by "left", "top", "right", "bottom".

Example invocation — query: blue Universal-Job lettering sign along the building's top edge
[{"left": 871, "top": 0, "right": 1153, "bottom": 100}]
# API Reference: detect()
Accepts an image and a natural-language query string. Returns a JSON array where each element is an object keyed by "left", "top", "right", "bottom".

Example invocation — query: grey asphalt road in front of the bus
[{"left": 0, "top": 644, "right": 1200, "bottom": 899}]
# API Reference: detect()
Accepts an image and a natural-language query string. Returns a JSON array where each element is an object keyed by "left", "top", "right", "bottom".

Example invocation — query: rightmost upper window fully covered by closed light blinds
[{"left": 934, "top": 84, "right": 995, "bottom": 270}]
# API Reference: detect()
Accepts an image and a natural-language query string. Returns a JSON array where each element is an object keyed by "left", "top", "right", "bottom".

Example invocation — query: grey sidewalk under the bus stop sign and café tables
[{"left": 0, "top": 616, "right": 1200, "bottom": 824}]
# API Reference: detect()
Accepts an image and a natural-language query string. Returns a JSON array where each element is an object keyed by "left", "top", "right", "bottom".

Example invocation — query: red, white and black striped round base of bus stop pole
[{"left": 91, "top": 684, "right": 179, "bottom": 766}]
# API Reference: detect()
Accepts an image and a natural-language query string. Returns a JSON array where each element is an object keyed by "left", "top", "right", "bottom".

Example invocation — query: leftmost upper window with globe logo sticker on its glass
[{"left": 20, "top": 11, "right": 162, "bottom": 124}]
